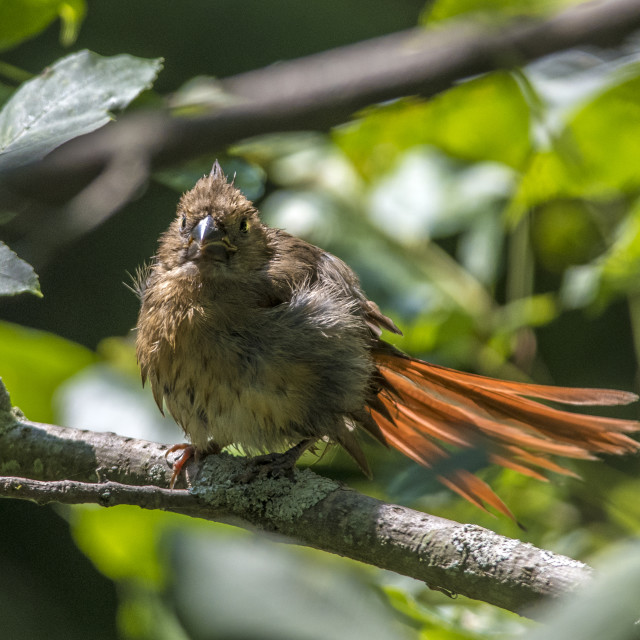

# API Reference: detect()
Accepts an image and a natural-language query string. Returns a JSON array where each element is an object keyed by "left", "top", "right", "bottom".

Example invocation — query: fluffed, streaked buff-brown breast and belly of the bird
[{"left": 137, "top": 272, "right": 374, "bottom": 452}]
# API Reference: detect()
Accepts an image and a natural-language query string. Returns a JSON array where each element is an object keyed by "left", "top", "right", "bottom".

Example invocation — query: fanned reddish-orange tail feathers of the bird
[{"left": 370, "top": 351, "right": 640, "bottom": 518}]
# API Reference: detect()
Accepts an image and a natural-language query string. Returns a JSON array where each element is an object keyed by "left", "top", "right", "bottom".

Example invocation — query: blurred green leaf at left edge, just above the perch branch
[{"left": 0, "top": 322, "right": 95, "bottom": 422}]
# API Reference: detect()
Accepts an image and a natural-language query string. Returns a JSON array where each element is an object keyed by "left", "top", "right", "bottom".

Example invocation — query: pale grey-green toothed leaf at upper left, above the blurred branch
[{"left": 0, "top": 50, "right": 162, "bottom": 169}]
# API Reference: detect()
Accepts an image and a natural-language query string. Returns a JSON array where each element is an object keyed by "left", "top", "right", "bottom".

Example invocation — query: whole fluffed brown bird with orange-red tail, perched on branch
[{"left": 135, "top": 161, "right": 640, "bottom": 519}]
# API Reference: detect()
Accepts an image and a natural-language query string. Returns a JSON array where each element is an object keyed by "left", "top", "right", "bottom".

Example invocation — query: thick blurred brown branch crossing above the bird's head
[{"left": 2, "top": 0, "right": 640, "bottom": 202}]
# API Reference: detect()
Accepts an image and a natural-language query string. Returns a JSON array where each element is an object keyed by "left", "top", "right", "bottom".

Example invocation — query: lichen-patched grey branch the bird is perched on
[{"left": 0, "top": 388, "right": 591, "bottom": 615}]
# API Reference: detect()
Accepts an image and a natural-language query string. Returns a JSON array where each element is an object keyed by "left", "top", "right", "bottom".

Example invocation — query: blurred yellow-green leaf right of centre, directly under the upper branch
[{"left": 334, "top": 72, "right": 531, "bottom": 176}]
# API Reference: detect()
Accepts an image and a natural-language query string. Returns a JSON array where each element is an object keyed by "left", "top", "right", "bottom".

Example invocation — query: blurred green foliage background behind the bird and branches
[{"left": 0, "top": 0, "right": 640, "bottom": 640}]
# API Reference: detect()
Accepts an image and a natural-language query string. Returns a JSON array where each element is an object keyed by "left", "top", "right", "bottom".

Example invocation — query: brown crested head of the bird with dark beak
[{"left": 157, "top": 162, "right": 272, "bottom": 278}]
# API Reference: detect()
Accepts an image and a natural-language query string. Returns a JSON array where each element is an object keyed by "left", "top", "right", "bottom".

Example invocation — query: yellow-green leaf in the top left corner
[{"left": 0, "top": 0, "right": 86, "bottom": 51}]
